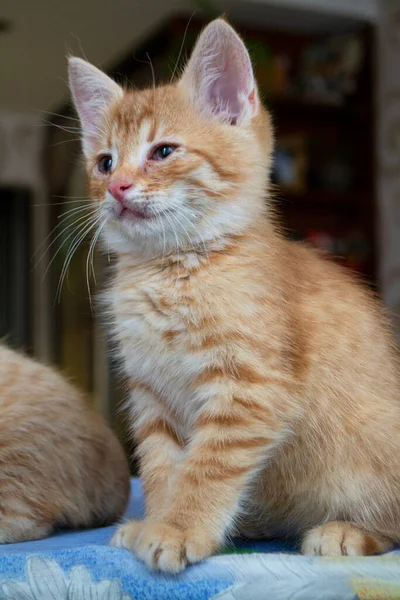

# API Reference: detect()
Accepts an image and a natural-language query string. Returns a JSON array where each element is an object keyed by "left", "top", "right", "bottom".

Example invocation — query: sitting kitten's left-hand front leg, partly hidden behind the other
[{"left": 111, "top": 385, "right": 183, "bottom": 549}]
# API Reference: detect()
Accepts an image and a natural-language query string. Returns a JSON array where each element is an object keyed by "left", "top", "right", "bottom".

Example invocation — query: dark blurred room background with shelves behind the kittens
[{"left": 0, "top": 0, "right": 400, "bottom": 460}]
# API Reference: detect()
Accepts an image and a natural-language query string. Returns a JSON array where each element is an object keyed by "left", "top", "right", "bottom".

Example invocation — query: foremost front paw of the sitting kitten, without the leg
[{"left": 134, "top": 521, "right": 216, "bottom": 573}]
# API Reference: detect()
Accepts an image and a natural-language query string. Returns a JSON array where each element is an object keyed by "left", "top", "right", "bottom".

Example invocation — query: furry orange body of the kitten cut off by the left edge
[{"left": 0, "top": 346, "right": 129, "bottom": 543}]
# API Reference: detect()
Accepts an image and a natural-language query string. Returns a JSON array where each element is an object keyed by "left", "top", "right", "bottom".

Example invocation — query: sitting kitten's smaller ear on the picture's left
[{"left": 68, "top": 56, "right": 123, "bottom": 156}]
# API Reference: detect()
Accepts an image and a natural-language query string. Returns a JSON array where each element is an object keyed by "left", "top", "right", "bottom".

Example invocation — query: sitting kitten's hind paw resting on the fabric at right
[{"left": 301, "top": 521, "right": 394, "bottom": 556}]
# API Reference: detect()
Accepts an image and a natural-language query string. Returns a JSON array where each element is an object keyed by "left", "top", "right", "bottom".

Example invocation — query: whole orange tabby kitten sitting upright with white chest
[{"left": 70, "top": 19, "right": 400, "bottom": 572}]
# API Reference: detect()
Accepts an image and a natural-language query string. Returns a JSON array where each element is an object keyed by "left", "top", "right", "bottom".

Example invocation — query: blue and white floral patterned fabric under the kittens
[{"left": 0, "top": 480, "right": 400, "bottom": 600}]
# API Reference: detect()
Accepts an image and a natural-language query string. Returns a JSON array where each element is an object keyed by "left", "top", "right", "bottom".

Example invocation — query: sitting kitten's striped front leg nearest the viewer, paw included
[{"left": 125, "top": 398, "right": 279, "bottom": 573}]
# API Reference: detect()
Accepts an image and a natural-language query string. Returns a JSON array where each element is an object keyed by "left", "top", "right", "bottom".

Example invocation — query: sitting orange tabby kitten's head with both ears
[{"left": 69, "top": 19, "right": 272, "bottom": 255}]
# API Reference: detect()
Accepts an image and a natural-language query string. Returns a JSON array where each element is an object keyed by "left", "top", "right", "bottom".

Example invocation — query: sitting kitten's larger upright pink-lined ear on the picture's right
[{"left": 179, "top": 19, "right": 259, "bottom": 124}]
